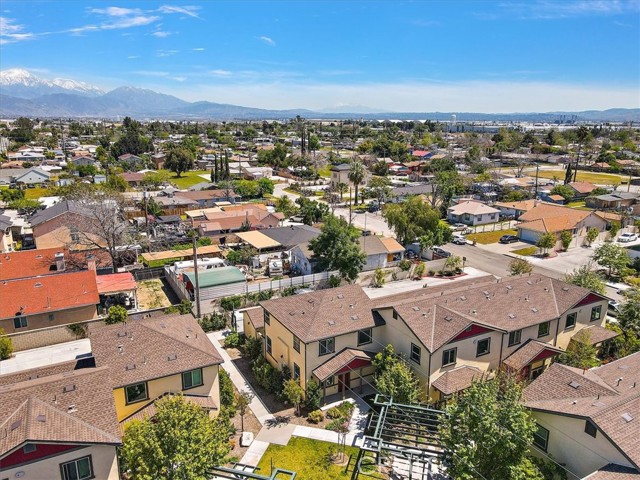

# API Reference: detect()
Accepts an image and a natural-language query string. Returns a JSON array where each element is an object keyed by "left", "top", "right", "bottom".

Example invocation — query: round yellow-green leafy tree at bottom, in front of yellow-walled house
[{"left": 120, "top": 395, "right": 231, "bottom": 480}]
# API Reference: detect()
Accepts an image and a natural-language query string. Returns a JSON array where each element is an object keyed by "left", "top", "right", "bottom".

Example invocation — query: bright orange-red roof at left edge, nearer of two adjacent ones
[{"left": 0, "top": 270, "right": 99, "bottom": 318}]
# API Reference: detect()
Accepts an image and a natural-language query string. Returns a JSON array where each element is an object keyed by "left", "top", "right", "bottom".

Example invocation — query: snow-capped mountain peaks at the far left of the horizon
[{"left": 0, "top": 68, "right": 105, "bottom": 98}]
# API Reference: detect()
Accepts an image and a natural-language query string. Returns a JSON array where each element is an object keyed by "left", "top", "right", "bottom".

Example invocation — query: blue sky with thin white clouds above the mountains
[{"left": 0, "top": 0, "right": 640, "bottom": 112}]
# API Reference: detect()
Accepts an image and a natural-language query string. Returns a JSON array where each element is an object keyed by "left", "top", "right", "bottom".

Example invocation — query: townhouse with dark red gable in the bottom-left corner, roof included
[{"left": 0, "top": 360, "right": 121, "bottom": 480}]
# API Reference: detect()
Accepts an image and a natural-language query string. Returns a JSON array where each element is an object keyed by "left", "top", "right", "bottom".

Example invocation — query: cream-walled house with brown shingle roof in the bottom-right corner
[{"left": 524, "top": 352, "right": 640, "bottom": 480}]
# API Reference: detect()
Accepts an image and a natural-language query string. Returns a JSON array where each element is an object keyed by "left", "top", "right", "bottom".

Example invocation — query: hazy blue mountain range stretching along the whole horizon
[{"left": 0, "top": 69, "right": 640, "bottom": 123}]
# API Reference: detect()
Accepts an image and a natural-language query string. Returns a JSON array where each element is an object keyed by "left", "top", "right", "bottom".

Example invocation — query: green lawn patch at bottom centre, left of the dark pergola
[{"left": 257, "top": 437, "right": 383, "bottom": 480}]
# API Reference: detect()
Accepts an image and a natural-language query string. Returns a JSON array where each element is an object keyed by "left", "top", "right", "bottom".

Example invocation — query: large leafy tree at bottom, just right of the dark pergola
[{"left": 439, "top": 376, "right": 542, "bottom": 480}]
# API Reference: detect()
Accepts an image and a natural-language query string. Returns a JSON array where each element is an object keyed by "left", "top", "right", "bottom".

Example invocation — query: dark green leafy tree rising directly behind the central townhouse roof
[{"left": 309, "top": 215, "right": 367, "bottom": 282}]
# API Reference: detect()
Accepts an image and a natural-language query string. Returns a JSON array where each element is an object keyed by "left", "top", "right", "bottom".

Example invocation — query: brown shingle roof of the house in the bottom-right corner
[{"left": 524, "top": 352, "right": 640, "bottom": 467}]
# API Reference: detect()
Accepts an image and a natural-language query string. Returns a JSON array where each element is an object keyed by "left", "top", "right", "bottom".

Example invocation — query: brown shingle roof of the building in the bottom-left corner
[{"left": 0, "top": 368, "right": 121, "bottom": 454}]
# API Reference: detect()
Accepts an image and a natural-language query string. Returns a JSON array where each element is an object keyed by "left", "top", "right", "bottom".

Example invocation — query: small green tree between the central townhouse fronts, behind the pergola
[{"left": 372, "top": 344, "right": 420, "bottom": 404}]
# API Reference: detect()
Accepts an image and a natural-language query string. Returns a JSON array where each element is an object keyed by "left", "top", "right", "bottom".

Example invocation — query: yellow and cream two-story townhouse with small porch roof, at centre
[{"left": 262, "top": 285, "right": 383, "bottom": 402}]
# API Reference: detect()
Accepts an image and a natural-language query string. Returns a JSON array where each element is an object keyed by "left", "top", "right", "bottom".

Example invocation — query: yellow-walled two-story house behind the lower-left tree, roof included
[{"left": 89, "top": 315, "right": 222, "bottom": 423}]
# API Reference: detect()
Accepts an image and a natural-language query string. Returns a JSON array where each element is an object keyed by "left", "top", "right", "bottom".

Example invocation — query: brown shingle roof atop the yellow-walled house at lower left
[{"left": 89, "top": 315, "right": 223, "bottom": 388}]
